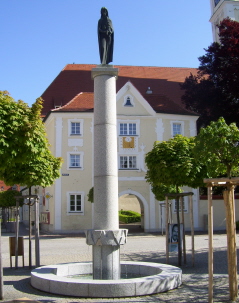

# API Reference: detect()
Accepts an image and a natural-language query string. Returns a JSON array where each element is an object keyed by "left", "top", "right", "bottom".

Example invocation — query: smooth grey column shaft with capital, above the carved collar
[{"left": 92, "top": 65, "right": 119, "bottom": 229}]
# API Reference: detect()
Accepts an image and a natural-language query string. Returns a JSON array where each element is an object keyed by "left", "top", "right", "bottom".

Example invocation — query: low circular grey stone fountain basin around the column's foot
[{"left": 31, "top": 261, "right": 182, "bottom": 298}]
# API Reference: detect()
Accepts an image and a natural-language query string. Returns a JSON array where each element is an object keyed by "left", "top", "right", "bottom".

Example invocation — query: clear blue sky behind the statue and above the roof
[{"left": 0, "top": 0, "right": 212, "bottom": 105}]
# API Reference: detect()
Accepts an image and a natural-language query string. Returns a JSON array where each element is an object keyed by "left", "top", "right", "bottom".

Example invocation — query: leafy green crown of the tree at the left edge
[{"left": 0, "top": 92, "right": 62, "bottom": 187}]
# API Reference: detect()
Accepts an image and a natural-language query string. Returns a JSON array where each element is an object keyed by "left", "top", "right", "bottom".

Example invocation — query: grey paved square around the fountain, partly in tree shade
[{"left": 2, "top": 233, "right": 239, "bottom": 303}]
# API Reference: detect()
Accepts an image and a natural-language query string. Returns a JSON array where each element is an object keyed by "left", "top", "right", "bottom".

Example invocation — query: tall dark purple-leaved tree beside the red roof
[{"left": 181, "top": 18, "right": 239, "bottom": 128}]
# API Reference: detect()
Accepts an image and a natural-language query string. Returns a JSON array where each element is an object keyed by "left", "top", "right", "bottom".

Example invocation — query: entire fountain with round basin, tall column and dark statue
[{"left": 31, "top": 8, "right": 182, "bottom": 298}]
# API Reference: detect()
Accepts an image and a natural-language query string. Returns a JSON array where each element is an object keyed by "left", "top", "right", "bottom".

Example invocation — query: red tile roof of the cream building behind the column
[{"left": 42, "top": 64, "right": 197, "bottom": 115}]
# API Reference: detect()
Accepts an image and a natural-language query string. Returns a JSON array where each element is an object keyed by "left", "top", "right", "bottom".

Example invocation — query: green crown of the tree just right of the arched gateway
[{"left": 145, "top": 135, "right": 206, "bottom": 200}]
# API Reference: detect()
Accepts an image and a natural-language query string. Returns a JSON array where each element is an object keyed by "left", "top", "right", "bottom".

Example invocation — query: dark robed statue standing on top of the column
[{"left": 98, "top": 7, "right": 114, "bottom": 64}]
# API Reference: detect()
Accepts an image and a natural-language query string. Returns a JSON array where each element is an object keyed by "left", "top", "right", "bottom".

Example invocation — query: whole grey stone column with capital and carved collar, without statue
[{"left": 86, "top": 65, "right": 127, "bottom": 280}]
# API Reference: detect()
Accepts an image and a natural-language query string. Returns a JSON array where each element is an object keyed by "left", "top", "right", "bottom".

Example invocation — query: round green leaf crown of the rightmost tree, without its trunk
[{"left": 195, "top": 118, "right": 239, "bottom": 178}]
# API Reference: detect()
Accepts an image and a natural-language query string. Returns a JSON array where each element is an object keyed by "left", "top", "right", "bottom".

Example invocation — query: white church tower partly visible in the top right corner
[{"left": 210, "top": 0, "right": 239, "bottom": 42}]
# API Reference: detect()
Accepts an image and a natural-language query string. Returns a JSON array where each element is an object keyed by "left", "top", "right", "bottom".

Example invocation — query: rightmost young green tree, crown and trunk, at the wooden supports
[{"left": 195, "top": 118, "right": 239, "bottom": 301}]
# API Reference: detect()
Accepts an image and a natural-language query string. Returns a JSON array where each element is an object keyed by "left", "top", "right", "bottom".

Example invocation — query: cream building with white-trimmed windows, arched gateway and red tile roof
[{"left": 38, "top": 64, "right": 200, "bottom": 232}]
